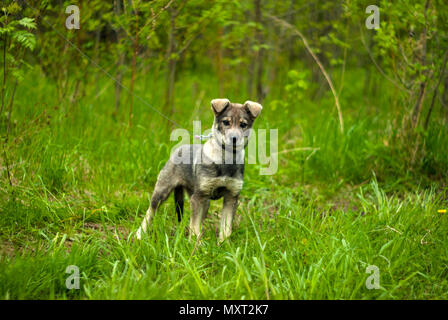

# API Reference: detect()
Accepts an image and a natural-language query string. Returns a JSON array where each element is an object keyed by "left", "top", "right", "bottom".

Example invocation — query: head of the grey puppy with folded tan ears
[{"left": 212, "top": 99, "right": 263, "bottom": 151}]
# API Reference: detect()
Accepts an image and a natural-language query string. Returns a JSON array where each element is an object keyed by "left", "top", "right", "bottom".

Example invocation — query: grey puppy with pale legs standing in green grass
[{"left": 136, "top": 99, "right": 262, "bottom": 242}]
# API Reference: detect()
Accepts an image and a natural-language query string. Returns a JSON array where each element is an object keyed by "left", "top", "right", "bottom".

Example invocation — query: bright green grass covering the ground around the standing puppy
[{"left": 0, "top": 66, "right": 448, "bottom": 299}]
